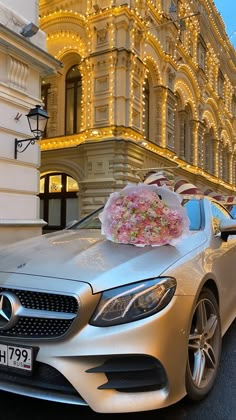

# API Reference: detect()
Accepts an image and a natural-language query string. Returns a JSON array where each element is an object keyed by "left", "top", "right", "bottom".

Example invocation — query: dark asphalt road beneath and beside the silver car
[{"left": 0, "top": 321, "right": 236, "bottom": 420}]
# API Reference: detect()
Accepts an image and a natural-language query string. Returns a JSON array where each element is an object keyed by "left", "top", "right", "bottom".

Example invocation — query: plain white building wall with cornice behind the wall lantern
[{"left": 0, "top": 0, "right": 59, "bottom": 245}]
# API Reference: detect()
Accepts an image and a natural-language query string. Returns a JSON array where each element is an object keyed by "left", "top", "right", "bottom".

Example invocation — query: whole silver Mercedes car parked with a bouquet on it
[{"left": 0, "top": 197, "right": 236, "bottom": 413}]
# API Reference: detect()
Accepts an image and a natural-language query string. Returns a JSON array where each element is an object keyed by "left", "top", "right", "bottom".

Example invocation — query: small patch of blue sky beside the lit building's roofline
[{"left": 214, "top": 0, "right": 236, "bottom": 48}]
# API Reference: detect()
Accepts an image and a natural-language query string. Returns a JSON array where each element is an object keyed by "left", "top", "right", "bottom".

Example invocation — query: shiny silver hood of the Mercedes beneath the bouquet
[{"left": 0, "top": 230, "right": 206, "bottom": 292}]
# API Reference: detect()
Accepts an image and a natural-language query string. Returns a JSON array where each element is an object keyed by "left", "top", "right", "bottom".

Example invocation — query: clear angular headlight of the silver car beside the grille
[{"left": 90, "top": 277, "right": 176, "bottom": 327}]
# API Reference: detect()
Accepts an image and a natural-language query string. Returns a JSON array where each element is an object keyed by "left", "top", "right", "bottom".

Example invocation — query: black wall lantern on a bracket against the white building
[{"left": 15, "top": 105, "right": 49, "bottom": 159}]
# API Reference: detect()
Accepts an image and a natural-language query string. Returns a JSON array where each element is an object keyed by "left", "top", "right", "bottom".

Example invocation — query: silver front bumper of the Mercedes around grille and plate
[{"left": 0, "top": 279, "right": 194, "bottom": 413}]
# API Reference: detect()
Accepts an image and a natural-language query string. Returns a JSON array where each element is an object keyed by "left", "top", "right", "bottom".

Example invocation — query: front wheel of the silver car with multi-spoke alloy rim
[{"left": 186, "top": 289, "right": 222, "bottom": 400}]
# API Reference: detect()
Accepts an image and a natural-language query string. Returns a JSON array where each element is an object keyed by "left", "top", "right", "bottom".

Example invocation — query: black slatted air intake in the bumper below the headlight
[{"left": 87, "top": 355, "right": 167, "bottom": 392}]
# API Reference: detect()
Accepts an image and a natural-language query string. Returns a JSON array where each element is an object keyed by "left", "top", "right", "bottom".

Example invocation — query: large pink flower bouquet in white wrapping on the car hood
[{"left": 99, "top": 184, "right": 189, "bottom": 246}]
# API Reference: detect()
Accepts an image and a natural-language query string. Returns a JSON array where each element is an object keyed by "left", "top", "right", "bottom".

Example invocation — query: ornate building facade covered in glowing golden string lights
[{"left": 39, "top": 0, "right": 236, "bottom": 229}]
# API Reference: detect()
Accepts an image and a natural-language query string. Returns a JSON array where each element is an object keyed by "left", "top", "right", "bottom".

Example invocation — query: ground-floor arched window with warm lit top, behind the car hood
[{"left": 39, "top": 172, "right": 79, "bottom": 232}]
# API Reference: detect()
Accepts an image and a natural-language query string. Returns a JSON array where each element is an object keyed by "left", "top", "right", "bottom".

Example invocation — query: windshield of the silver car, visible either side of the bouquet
[{"left": 69, "top": 199, "right": 202, "bottom": 231}]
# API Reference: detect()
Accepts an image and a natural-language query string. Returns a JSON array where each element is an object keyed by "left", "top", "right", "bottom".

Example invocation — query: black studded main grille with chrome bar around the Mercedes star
[{"left": 0, "top": 287, "right": 79, "bottom": 338}]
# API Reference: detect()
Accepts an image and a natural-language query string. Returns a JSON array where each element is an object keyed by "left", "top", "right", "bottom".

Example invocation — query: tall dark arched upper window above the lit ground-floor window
[{"left": 65, "top": 65, "right": 82, "bottom": 135}]
